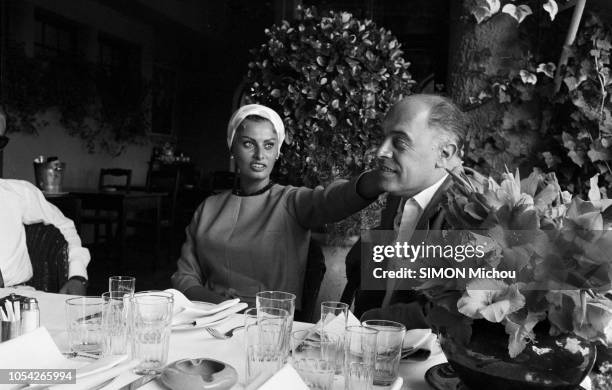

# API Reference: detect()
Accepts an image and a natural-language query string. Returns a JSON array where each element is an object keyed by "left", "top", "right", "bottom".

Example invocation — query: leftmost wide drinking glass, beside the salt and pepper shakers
[{"left": 66, "top": 297, "right": 104, "bottom": 354}]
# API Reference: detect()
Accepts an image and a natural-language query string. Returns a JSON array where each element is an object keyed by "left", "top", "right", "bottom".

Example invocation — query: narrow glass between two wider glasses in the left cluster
[{"left": 102, "top": 291, "right": 130, "bottom": 355}]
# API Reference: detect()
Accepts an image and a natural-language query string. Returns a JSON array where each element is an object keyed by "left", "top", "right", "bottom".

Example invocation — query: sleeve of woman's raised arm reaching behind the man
[{"left": 288, "top": 177, "right": 375, "bottom": 229}]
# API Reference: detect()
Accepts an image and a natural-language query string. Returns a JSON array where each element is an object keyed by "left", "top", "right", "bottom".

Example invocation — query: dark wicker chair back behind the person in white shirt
[{"left": 25, "top": 223, "right": 68, "bottom": 292}]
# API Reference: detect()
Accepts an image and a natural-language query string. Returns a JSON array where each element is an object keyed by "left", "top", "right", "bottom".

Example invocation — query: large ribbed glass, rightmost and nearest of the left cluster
[{"left": 131, "top": 292, "right": 174, "bottom": 375}]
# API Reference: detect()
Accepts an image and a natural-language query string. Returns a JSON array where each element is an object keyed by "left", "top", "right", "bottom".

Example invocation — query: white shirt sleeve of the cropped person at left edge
[{"left": 11, "top": 180, "right": 91, "bottom": 279}]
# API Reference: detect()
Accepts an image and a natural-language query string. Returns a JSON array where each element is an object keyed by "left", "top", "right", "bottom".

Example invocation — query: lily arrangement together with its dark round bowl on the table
[{"left": 419, "top": 166, "right": 612, "bottom": 389}]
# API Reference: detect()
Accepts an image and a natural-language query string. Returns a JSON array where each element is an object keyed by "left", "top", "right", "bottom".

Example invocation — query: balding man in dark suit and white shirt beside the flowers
[{"left": 343, "top": 95, "right": 465, "bottom": 322}]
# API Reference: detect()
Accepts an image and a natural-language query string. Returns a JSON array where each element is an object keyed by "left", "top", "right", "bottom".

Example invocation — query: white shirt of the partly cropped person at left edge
[{"left": 0, "top": 179, "right": 90, "bottom": 286}]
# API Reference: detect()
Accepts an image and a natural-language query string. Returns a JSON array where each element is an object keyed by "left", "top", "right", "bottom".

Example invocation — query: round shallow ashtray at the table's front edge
[{"left": 160, "top": 358, "right": 238, "bottom": 390}]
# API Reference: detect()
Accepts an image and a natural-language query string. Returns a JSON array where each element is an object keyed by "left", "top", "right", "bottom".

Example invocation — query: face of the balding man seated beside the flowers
[{"left": 377, "top": 98, "right": 445, "bottom": 197}]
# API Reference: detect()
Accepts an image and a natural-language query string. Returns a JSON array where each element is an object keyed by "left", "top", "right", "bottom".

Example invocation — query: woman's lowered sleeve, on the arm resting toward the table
[{"left": 172, "top": 202, "right": 206, "bottom": 292}]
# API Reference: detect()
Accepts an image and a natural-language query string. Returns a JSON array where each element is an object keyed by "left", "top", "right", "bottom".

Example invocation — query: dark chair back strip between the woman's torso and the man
[{"left": 295, "top": 240, "right": 327, "bottom": 322}]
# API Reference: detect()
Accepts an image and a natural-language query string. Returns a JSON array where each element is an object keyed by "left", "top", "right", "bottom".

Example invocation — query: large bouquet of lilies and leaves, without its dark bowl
[{"left": 419, "top": 168, "right": 612, "bottom": 358}]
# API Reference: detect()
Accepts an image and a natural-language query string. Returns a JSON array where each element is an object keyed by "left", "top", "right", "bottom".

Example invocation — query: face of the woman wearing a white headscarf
[{"left": 232, "top": 119, "right": 278, "bottom": 181}]
